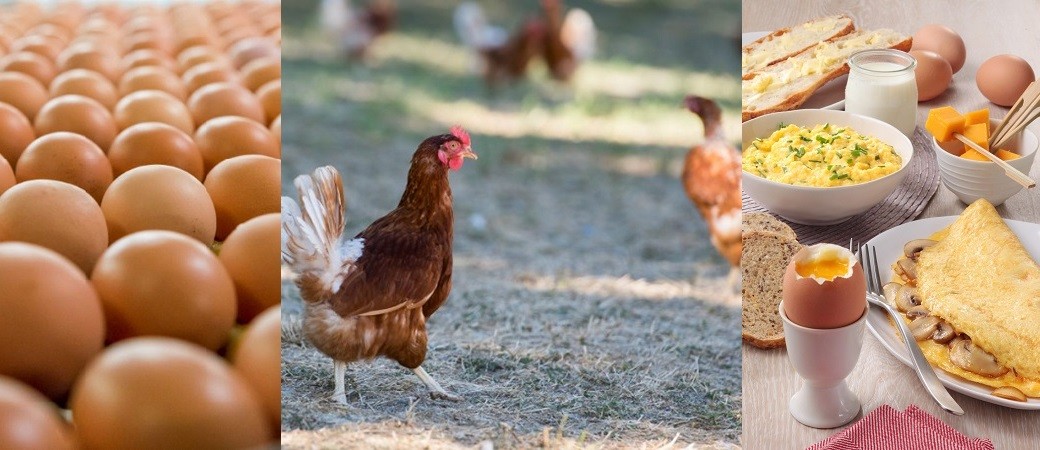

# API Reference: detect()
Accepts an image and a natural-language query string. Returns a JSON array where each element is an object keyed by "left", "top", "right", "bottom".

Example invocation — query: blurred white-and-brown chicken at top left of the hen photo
[{"left": 319, "top": 0, "right": 397, "bottom": 58}]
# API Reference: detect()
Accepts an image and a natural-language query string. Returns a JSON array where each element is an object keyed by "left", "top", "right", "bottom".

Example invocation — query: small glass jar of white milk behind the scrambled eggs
[{"left": 846, "top": 49, "right": 917, "bottom": 136}]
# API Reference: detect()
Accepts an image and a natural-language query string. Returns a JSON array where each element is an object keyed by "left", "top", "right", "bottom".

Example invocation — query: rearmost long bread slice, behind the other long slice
[{"left": 740, "top": 15, "right": 855, "bottom": 75}]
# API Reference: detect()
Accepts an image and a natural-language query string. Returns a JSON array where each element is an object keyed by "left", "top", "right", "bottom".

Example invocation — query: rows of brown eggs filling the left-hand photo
[{"left": 0, "top": 0, "right": 281, "bottom": 449}]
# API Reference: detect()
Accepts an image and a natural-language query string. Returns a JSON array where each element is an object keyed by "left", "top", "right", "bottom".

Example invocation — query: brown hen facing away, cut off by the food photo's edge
[{"left": 682, "top": 96, "right": 743, "bottom": 281}]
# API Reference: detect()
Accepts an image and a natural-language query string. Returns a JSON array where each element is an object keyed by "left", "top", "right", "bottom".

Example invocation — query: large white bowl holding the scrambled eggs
[{"left": 742, "top": 109, "right": 913, "bottom": 226}]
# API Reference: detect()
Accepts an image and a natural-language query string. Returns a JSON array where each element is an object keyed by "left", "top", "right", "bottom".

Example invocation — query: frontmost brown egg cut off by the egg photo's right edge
[{"left": 231, "top": 307, "right": 282, "bottom": 439}]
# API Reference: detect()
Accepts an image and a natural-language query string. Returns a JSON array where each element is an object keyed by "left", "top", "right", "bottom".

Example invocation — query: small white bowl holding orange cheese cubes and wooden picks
[{"left": 932, "top": 118, "right": 1038, "bottom": 206}]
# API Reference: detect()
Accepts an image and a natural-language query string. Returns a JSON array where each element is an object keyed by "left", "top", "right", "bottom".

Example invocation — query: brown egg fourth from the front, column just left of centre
[{"left": 15, "top": 131, "right": 112, "bottom": 203}]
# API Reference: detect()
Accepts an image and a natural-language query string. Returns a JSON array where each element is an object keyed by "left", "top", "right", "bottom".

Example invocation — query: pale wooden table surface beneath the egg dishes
[{"left": 743, "top": 0, "right": 1040, "bottom": 450}]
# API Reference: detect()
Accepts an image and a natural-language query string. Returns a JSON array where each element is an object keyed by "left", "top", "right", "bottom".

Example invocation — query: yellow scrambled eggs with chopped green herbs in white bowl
[{"left": 743, "top": 124, "right": 903, "bottom": 187}]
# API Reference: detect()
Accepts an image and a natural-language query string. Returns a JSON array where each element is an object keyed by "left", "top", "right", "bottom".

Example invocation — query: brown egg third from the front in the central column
[{"left": 101, "top": 164, "right": 216, "bottom": 245}]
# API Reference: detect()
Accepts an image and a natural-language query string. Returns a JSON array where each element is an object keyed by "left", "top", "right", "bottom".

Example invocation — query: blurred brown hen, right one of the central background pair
[{"left": 542, "top": 0, "right": 596, "bottom": 81}]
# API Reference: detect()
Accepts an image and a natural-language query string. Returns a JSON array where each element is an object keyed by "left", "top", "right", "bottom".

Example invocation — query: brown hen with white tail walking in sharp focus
[{"left": 282, "top": 127, "right": 476, "bottom": 404}]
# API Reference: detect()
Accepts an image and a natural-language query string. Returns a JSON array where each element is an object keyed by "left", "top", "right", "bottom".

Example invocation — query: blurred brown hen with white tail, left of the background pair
[{"left": 454, "top": 2, "right": 545, "bottom": 88}]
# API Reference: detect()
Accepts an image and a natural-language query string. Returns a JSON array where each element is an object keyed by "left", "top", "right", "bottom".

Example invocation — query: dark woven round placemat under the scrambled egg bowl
[{"left": 742, "top": 127, "right": 939, "bottom": 245}]
